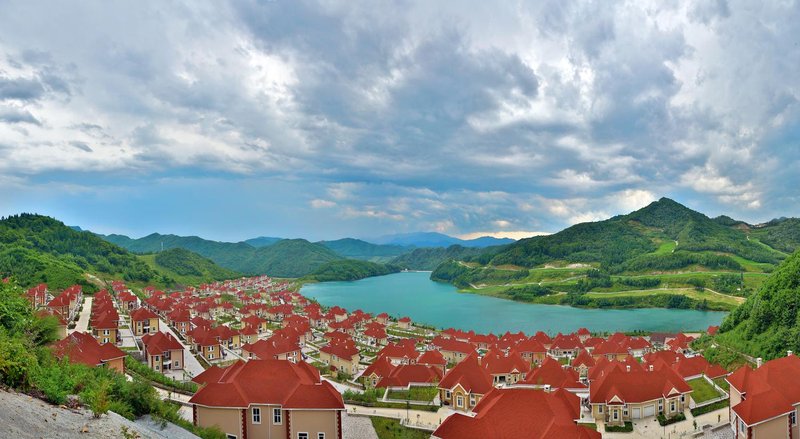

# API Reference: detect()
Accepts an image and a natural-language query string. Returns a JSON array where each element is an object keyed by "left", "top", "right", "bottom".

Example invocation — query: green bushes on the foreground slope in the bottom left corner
[{"left": 0, "top": 283, "right": 225, "bottom": 439}]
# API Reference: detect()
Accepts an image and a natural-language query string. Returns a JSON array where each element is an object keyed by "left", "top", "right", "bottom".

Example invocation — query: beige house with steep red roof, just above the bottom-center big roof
[{"left": 439, "top": 353, "right": 493, "bottom": 412}]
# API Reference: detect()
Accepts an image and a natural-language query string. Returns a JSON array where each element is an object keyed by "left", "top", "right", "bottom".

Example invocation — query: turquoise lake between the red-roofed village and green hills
[{"left": 301, "top": 272, "right": 726, "bottom": 334}]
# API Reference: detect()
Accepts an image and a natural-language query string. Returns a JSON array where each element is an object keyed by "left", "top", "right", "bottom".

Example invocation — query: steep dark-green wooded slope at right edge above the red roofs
[{"left": 716, "top": 251, "right": 800, "bottom": 359}]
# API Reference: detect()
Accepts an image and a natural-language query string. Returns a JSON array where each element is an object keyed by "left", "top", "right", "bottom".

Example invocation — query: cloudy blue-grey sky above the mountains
[{"left": 0, "top": 0, "right": 800, "bottom": 241}]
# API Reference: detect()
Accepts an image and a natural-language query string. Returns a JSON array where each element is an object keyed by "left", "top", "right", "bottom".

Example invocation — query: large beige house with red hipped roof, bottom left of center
[{"left": 194, "top": 360, "right": 344, "bottom": 439}]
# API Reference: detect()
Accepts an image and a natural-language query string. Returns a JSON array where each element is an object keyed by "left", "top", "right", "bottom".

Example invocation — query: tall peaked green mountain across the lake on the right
[{"left": 466, "top": 198, "right": 784, "bottom": 273}]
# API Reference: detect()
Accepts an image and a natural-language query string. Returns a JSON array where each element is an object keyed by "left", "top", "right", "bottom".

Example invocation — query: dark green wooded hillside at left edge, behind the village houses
[{"left": 0, "top": 214, "right": 157, "bottom": 290}]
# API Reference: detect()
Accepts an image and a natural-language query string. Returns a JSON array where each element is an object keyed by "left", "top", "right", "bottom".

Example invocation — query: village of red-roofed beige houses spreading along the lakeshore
[{"left": 27, "top": 276, "right": 800, "bottom": 439}]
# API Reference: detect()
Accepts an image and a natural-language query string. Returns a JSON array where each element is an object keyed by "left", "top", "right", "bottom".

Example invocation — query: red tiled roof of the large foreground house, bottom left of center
[{"left": 194, "top": 360, "right": 344, "bottom": 410}]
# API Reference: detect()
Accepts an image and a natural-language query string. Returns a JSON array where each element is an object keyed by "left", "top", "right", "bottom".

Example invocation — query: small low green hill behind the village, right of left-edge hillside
[{"left": 139, "top": 248, "right": 241, "bottom": 285}]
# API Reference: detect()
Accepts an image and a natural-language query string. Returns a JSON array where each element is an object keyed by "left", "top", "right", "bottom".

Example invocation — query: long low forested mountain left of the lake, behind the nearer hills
[{"left": 101, "top": 233, "right": 343, "bottom": 277}]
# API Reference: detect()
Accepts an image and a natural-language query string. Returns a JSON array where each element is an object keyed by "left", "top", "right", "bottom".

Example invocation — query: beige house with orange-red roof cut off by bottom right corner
[{"left": 726, "top": 351, "right": 800, "bottom": 439}]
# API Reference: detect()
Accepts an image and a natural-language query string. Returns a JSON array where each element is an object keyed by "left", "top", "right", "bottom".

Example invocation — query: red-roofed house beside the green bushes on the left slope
[{"left": 53, "top": 332, "right": 127, "bottom": 373}]
